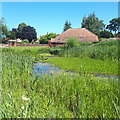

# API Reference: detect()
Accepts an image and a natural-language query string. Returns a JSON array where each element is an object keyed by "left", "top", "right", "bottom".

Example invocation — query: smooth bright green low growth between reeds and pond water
[{"left": 46, "top": 57, "right": 118, "bottom": 75}]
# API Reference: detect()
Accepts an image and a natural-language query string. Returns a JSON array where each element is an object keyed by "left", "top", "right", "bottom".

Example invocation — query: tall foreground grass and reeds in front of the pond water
[{"left": 0, "top": 51, "right": 119, "bottom": 119}]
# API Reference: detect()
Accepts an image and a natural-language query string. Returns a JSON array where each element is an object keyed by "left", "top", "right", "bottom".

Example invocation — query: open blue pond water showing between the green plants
[{"left": 33, "top": 62, "right": 118, "bottom": 79}]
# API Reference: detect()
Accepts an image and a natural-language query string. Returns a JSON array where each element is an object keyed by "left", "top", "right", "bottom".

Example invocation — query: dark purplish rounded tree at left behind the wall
[{"left": 19, "top": 26, "right": 37, "bottom": 42}]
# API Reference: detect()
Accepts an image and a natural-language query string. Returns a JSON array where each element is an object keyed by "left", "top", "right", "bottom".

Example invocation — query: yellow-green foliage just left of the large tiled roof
[{"left": 39, "top": 33, "right": 59, "bottom": 44}]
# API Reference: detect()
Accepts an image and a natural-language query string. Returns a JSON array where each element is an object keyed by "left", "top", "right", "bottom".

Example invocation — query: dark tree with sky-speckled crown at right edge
[{"left": 106, "top": 17, "right": 120, "bottom": 34}]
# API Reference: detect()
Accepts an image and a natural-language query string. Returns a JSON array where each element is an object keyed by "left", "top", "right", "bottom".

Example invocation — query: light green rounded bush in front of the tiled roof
[{"left": 65, "top": 37, "right": 80, "bottom": 47}]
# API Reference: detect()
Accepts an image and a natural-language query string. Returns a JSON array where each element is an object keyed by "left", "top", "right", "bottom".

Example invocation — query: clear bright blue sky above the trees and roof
[{"left": 2, "top": 2, "right": 118, "bottom": 37}]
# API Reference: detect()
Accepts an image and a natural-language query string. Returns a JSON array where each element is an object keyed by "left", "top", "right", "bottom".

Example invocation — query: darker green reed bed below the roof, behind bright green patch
[{"left": 58, "top": 40, "right": 118, "bottom": 61}]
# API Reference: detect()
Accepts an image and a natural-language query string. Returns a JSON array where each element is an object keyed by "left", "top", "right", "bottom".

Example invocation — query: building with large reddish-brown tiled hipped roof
[{"left": 51, "top": 28, "right": 99, "bottom": 46}]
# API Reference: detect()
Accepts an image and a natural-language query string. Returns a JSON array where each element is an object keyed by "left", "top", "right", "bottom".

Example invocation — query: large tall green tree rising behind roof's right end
[{"left": 81, "top": 13, "right": 105, "bottom": 36}]
